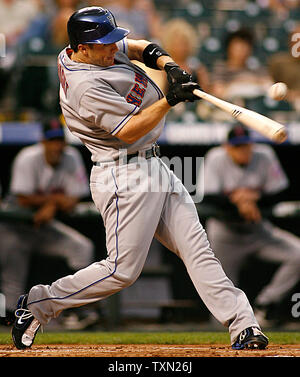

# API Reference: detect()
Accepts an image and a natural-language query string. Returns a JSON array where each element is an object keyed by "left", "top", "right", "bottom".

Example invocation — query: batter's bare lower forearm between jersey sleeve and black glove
[{"left": 116, "top": 98, "right": 171, "bottom": 144}]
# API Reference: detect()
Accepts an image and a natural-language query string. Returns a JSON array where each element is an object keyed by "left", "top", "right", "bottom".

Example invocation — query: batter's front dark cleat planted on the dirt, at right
[{"left": 231, "top": 327, "right": 269, "bottom": 350}]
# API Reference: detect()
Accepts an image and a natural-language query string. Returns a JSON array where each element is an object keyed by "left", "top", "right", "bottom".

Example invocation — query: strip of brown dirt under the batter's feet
[{"left": 0, "top": 344, "right": 300, "bottom": 357}]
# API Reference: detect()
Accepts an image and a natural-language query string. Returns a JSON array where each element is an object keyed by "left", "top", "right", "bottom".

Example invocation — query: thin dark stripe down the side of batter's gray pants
[{"left": 27, "top": 168, "right": 119, "bottom": 306}]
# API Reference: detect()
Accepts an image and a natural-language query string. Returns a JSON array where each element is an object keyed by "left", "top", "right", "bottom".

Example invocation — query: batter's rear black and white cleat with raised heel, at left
[{"left": 12, "top": 295, "right": 41, "bottom": 349}]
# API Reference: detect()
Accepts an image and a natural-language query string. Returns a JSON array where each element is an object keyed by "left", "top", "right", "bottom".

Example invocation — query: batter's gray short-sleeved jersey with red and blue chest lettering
[{"left": 58, "top": 40, "right": 164, "bottom": 161}]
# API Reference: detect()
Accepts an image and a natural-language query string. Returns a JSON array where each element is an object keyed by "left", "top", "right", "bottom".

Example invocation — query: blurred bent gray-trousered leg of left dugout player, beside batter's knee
[{"left": 36, "top": 220, "right": 94, "bottom": 271}]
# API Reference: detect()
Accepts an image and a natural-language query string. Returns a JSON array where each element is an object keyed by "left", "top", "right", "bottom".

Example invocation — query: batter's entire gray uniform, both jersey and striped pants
[{"left": 28, "top": 41, "right": 259, "bottom": 341}]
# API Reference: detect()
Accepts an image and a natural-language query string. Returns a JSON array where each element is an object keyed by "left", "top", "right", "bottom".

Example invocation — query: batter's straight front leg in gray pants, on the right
[{"left": 156, "top": 167, "right": 259, "bottom": 342}]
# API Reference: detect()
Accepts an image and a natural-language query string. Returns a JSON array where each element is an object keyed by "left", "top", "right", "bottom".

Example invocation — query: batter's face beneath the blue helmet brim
[{"left": 86, "top": 43, "right": 118, "bottom": 67}]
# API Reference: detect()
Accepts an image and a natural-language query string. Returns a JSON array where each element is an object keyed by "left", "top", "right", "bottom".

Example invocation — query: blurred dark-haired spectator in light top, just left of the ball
[{"left": 211, "top": 29, "right": 271, "bottom": 101}]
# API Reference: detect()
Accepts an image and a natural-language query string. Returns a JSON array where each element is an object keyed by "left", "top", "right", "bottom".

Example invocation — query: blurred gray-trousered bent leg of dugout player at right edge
[{"left": 256, "top": 223, "right": 300, "bottom": 306}]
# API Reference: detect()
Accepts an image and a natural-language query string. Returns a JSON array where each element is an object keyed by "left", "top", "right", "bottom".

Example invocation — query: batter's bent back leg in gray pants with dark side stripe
[{"left": 28, "top": 163, "right": 165, "bottom": 324}]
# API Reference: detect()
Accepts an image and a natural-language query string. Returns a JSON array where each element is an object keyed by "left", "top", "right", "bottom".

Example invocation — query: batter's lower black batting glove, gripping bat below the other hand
[{"left": 166, "top": 81, "right": 201, "bottom": 106}]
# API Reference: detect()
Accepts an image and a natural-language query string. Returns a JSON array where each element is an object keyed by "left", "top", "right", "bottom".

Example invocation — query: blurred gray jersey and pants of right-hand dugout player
[{"left": 204, "top": 144, "right": 300, "bottom": 305}]
